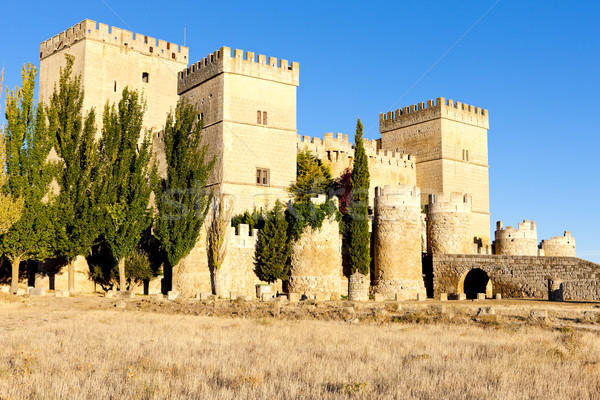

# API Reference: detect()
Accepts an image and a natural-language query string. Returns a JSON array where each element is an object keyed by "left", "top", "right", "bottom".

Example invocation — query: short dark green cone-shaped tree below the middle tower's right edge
[{"left": 255, "top": 201, "right": 290, "bottom": 282}]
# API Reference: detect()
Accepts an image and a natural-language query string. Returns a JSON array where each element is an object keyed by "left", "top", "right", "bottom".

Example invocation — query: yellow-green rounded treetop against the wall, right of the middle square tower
[{"left": 288, "top": 149, "right": 334, "bottom": 202}]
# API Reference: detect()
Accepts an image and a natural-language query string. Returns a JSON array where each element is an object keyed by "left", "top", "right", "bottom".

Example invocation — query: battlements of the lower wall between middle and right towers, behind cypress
[{"left": 297, "top": 132, "right": 416, "bottom": 168}]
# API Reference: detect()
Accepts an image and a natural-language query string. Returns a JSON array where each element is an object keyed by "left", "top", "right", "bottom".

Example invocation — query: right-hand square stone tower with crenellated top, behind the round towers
[{"left": 379, "top": 97, "right": 490, "bottom": 243}]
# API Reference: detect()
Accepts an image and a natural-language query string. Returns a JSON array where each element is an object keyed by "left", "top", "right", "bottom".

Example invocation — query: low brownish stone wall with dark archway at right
[{"left": 432, "top": 254, "right": 600, "bottom": 300}]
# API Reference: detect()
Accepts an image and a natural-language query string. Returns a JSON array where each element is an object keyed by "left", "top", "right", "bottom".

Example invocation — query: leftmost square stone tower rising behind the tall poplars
[{"left": 39, "top": 19, "right": 189, "bottom": 135}]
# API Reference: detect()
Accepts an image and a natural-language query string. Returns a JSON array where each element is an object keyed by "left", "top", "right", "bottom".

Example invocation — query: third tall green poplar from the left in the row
[{"left": 98, "top": 88, "right": 156, "bottom": 290}]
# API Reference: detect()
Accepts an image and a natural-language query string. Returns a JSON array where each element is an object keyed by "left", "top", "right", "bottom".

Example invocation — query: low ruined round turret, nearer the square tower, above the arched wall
[{"left": 494, "top": 220, "right": 538, "bottom": 256}]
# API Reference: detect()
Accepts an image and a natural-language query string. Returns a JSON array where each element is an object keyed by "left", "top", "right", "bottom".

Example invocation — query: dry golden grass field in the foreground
[{"left": 0, "top": 297, "right": 600, "bottom": 400}]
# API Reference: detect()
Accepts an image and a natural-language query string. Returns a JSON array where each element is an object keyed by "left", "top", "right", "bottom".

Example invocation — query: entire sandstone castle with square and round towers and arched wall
[{"left": 39, "top": 20, "right": 600, "bottom": 299}]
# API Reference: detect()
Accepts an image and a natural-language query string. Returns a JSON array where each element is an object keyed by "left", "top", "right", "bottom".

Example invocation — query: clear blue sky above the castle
[{"left": 0, "top": 0, "right": 600, "bottom": 262}]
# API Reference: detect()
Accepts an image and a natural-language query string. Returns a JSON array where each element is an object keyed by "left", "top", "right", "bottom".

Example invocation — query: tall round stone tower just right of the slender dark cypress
[{"left": 373, "top": 185, "right": 425, "bottom": 300}]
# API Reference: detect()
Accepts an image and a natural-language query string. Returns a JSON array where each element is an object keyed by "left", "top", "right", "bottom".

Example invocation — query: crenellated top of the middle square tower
[{"left": 177, "top": 47, "right": 300, "bottom": 94}]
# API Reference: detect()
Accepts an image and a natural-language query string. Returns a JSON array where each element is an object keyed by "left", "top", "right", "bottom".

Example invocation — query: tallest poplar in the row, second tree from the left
[{"left": 47, "top": 55, "right": 99, "bottom": 291}]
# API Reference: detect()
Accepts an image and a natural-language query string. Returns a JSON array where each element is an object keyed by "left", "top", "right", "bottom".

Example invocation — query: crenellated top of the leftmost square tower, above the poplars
[{"left": 40, "top": 19, "right": 189, "bottom": 61}]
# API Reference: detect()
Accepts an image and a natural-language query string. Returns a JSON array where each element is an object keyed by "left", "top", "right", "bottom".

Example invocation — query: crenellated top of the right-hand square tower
[{"left": 379, "top": 97, "right": 489, "bottom": 133}]
